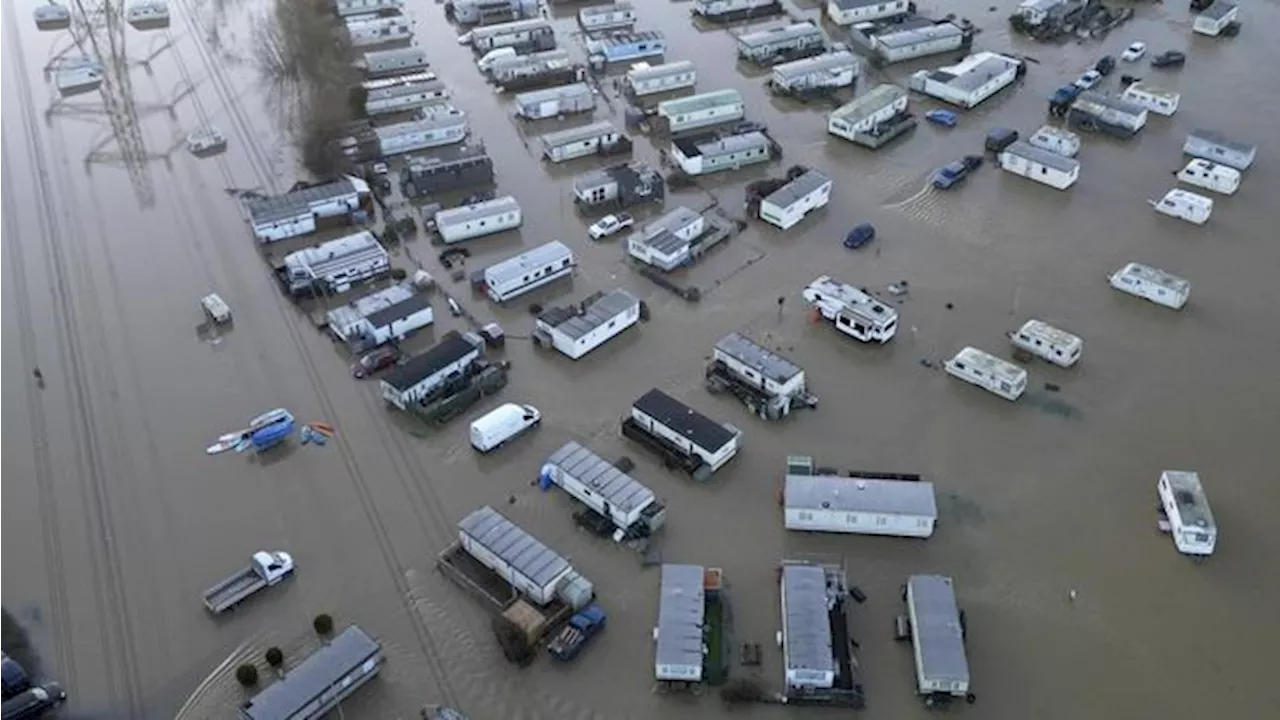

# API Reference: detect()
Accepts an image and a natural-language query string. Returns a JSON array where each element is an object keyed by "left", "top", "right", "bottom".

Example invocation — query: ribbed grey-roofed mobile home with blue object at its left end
[{"left": 539, "top": 442, "right": 667, "bottom": 538}]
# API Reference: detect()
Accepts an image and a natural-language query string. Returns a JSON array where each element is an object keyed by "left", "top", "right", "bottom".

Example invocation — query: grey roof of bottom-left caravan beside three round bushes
[{"left": 241, "top": 625, "right": 381, "bottom": 720}]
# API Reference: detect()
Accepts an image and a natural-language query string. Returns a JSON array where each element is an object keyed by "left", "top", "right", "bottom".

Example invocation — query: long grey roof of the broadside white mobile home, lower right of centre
[{"left": 783, "top": 475, "right": 938, "bottom": 519}]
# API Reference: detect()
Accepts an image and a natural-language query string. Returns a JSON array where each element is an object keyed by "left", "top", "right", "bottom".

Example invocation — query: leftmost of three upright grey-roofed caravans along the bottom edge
[{"left": 653, "top": 564, "right": 707, "bottom": 683}]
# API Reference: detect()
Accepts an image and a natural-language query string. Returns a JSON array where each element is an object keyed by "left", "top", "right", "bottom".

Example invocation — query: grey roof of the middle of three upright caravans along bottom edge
[{"left": 782, "top": 565, "right": 836, "bottom": 673}]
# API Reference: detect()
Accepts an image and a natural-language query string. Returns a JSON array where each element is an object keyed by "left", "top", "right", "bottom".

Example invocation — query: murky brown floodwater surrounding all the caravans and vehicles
[{"left": 0, "top": 0, "right": 1280, "bottom": 720}]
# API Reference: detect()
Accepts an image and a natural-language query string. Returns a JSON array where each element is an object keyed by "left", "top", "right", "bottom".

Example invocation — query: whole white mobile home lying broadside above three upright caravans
[{"left": 782, "top": 474, "right": 938, "bottom": 538}]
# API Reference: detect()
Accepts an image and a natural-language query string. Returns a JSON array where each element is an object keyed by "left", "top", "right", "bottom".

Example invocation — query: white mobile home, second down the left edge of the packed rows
[{"left": 282, "top": 231, "right": 392, "bottom": 296}]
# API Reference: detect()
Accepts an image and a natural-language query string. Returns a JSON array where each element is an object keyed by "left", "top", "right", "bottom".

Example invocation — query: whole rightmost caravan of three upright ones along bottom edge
[{"left": 906, "top": 575, "right": 973, "bottom": 706}]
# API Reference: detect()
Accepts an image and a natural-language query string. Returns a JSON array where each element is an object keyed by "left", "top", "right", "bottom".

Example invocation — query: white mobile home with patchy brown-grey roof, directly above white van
[{"left": 534, "top": 290, "right": 640, "bottom": 360}]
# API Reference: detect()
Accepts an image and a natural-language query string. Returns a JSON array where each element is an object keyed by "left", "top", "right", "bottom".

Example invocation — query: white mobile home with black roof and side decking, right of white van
[{"left": 622, "top": 388, "right": 742, "bottom": 480}]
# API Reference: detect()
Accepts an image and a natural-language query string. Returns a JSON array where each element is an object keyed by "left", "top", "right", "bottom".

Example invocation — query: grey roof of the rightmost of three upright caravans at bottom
[{"left": 906, "top": 575, "right": 969, "bottom": 682}]
